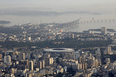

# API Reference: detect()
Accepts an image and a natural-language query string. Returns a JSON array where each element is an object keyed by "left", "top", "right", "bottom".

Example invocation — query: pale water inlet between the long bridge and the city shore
[{"left": 67, "top": 21, "right": 116, "bottom": 32}]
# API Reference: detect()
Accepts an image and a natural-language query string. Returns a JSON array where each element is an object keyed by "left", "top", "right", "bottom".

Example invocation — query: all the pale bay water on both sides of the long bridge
[{"left": 0, "top": 14, "right": 116, "bottom": 32}]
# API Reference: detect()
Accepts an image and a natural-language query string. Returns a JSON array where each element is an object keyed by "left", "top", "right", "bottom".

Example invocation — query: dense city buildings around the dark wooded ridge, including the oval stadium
[{"left": 0, "top": 22, "right": 116, "bottom": 77}]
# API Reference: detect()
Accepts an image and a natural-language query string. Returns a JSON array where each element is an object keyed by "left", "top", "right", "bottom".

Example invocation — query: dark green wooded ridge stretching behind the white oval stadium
[{"left": 0, "top": 38, "right": 111, "bottom": 49}]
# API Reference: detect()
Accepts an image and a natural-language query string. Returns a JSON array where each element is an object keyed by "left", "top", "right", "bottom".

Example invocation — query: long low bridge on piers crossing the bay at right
[{"left": 79, "top": 19, "right": 116, "bottom": 24}]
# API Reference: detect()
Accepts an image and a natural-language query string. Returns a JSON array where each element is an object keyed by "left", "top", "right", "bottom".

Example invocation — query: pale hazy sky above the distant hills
[{"left": 0, "top": 0, "right": 116, "bottom": 11}]
